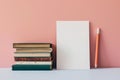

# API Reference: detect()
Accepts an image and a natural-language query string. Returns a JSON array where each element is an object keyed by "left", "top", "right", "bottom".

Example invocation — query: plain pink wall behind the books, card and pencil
[{"left": 0, "top": 0, "right": 120, "bottom": 67}]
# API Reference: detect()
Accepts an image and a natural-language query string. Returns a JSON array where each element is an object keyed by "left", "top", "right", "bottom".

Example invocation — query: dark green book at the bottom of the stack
[{"left": 12, "top": 64, "right": 52, "bottom": 70}]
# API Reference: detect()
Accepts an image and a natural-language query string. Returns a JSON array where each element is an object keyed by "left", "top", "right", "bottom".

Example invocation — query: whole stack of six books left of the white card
[{"left": 12, "top": 43, "right": 53, "bottom": 70}]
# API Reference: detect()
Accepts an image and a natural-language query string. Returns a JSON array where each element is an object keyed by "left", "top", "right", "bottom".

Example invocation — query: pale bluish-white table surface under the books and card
[{"left": 0, "top": 68, "right": 120, "bottom": 80}]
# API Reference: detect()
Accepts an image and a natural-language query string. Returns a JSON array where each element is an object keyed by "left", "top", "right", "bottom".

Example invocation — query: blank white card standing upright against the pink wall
[{"left": 56, "top": 21, "right": 90, "bottom": 70}]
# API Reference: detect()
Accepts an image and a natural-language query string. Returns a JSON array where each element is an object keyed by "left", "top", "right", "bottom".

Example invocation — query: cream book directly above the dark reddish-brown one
[{"left": 14, "top": 53, "right": 52, "bottom": 57}]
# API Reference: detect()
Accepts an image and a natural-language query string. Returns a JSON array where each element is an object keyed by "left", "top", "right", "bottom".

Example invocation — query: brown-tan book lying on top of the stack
[{"left": 13, "top": 43, "right": 52, "bottom": 48}]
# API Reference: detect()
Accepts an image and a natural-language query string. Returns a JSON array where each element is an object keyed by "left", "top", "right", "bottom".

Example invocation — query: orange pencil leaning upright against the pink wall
[{"left": 94, "top": 28, "right": 100, "bottom": 68}]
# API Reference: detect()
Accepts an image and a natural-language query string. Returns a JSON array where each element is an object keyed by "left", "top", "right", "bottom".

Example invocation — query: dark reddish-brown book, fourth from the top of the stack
[{"left": 15, "top": 57, "right": 52, "bottom": 61}]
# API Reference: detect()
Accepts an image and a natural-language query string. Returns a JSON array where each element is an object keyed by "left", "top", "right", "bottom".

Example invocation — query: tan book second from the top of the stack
[{"left": 16, "top": 48, "right": 52, "bottom": 52}]
